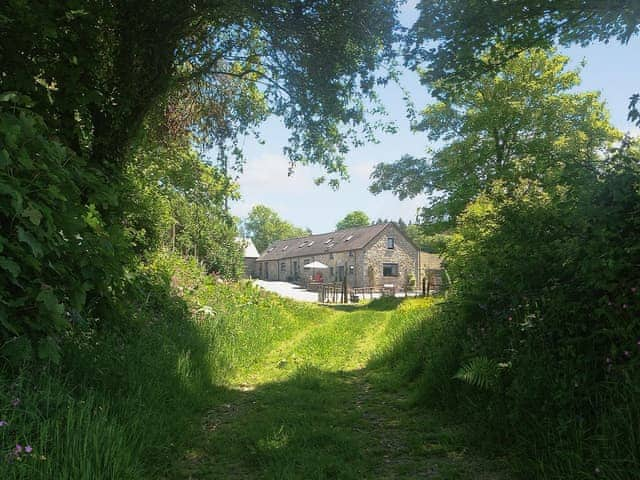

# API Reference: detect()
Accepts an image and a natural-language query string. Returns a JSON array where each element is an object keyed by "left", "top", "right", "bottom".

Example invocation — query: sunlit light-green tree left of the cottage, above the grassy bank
[{"left": 126, "top": 136, "right": 242, "bottom": 279}]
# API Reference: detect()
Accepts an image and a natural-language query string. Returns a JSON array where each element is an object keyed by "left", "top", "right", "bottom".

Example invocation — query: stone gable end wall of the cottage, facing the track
[{"left": 363, "top": 225, "right": 419, "bottom": 288}]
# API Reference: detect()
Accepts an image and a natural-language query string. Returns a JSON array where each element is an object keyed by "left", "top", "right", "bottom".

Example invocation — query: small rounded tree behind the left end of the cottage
[{"left": 244, "top": 205, "right": 311, "bottom": 252}]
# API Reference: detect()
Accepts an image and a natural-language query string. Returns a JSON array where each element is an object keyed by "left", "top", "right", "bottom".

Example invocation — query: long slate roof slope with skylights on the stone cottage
[{"left": 258, "top": 223, "right": 390, "bottom": 262}]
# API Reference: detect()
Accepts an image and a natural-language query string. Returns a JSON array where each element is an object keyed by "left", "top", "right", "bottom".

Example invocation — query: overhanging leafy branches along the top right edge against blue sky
[{"left": 406, "top": 0, "right": 640, "bottom": 124}]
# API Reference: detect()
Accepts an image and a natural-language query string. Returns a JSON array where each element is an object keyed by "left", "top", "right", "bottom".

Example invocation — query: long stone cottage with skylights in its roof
[{"left": 255, "top": 223, "right": 420, "bottom": 288}]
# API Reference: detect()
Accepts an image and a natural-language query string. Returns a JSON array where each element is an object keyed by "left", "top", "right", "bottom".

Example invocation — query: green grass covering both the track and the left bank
[{"left": 0, "top": 258, "right": 500, "bottom": 480}]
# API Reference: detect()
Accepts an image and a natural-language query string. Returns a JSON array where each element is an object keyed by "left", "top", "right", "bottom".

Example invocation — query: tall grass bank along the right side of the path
[{"left": 372, "top": 303, "right": 640, "bottom": 480}]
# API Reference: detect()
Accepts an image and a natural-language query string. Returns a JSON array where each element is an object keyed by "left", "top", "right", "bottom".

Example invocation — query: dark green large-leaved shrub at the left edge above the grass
[{"left": 0, "top": 102, "right": 135, "bottom": 364}]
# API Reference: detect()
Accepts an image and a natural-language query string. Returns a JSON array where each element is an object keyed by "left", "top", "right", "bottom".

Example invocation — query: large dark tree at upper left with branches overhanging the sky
[{"left": 0, "top": 0, "right": 398, "bottom": 175}]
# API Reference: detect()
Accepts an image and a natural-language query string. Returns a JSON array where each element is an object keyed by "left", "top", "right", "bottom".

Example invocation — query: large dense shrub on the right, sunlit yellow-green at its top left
[{"left": 438, "top": 145, "right": 640, "bottom": 478}]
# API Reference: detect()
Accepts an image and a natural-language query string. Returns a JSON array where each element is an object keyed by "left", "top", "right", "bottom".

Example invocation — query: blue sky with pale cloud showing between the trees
[{"left": 231, "top": 1, "right": 640, "bottom": 233}]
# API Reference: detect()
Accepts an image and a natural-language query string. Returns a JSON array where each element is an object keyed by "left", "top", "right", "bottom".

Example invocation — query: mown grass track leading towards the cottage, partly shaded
[{"left": 167, "top": 298, "right": 505, "bottom": 480}]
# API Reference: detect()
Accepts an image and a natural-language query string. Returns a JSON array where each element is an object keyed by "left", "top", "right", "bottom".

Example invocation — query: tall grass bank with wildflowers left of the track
[{"left": 0, "top": 253, "right": 318, "bottom": 480}]
